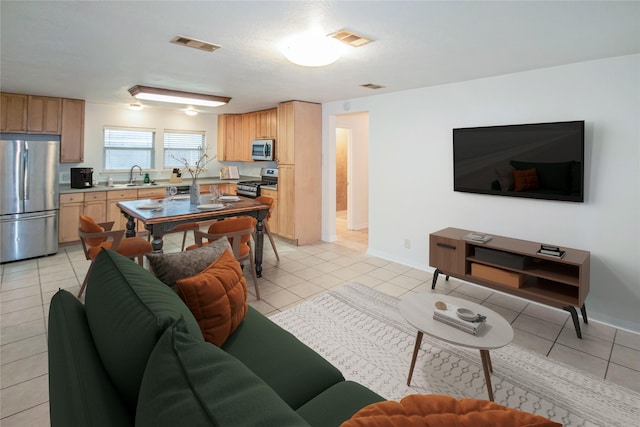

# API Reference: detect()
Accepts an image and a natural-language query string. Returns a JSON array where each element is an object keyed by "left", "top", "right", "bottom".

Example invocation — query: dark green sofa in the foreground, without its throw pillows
[{"left": 49, "top": 250, "right": 384, "bottom": 427}]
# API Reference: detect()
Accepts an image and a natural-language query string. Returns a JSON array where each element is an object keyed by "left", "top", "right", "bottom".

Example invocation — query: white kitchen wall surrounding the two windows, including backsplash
[{"left": 60, "top": 102, "right": 275, "bottom": 183}]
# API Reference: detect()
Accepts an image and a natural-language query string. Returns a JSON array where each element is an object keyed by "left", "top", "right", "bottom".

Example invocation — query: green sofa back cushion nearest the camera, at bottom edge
[{"left": 136, "top": 320, "right": 307, "bottom": 427}]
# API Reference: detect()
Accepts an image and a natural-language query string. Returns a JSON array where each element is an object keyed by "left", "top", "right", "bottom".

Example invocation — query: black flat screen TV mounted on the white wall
[{"left": 453, "top": 121, "right": 584, "bottom": 202}]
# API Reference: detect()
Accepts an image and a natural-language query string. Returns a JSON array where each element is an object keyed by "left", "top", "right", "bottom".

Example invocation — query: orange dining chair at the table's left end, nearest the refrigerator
[{"left": 78, "top": 215, "right": 152, "bottom": 298}]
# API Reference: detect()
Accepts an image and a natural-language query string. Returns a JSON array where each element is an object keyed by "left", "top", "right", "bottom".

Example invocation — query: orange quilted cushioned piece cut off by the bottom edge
[{"left": 340, "top": 394, "right": 562, "bottom": 427}]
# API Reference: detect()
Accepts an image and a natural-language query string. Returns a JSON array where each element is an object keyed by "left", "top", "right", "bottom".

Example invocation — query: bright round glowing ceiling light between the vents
[{"left": 279, "top": 30, "right": 344, "bottom": 67}]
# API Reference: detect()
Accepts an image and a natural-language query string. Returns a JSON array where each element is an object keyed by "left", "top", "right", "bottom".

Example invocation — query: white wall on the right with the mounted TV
[{"left": 323, "top": 55, "right": 640, "bottom": 331}]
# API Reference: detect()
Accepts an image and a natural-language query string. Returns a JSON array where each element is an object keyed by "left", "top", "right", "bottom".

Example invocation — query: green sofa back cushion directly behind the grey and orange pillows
[{"left": 85, "top": 249, "right": 203, "bottom": 413}]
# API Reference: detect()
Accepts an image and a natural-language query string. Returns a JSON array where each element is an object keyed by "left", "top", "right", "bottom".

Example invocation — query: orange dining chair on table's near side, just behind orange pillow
[{"left": 187, "top": 216, "right": 260, "bottom": 300}]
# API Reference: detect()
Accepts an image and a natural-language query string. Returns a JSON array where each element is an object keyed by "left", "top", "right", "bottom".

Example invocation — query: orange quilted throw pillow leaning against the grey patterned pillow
[{"left": 176, "top": 249, "right": 247, "bottom": 347}]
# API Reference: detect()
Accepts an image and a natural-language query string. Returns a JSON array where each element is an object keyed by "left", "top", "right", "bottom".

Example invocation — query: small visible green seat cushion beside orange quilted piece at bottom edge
[{"left": 296, "top": 381, "right": 385, "bottom": 427}]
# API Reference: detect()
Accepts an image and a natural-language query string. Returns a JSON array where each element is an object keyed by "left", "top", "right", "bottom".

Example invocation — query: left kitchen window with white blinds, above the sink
[{"left": 104, "top": 128, "right": 155, "bottom": 170}]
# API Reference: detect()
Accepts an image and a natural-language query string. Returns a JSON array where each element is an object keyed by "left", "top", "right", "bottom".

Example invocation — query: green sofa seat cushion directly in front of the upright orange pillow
[{"left": 222, "top": 307, "right": 344, "bottom": 409}]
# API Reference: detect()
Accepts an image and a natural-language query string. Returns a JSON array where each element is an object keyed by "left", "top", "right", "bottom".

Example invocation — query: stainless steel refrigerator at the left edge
[{"left": 0, "top": 134, "right": 60, "bottom": 262}]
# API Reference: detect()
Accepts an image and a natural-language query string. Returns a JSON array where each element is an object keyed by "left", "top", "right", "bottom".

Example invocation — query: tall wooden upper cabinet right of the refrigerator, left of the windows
[{"left": 60, "top": 99, "right": 84, "bottom": 163}]
